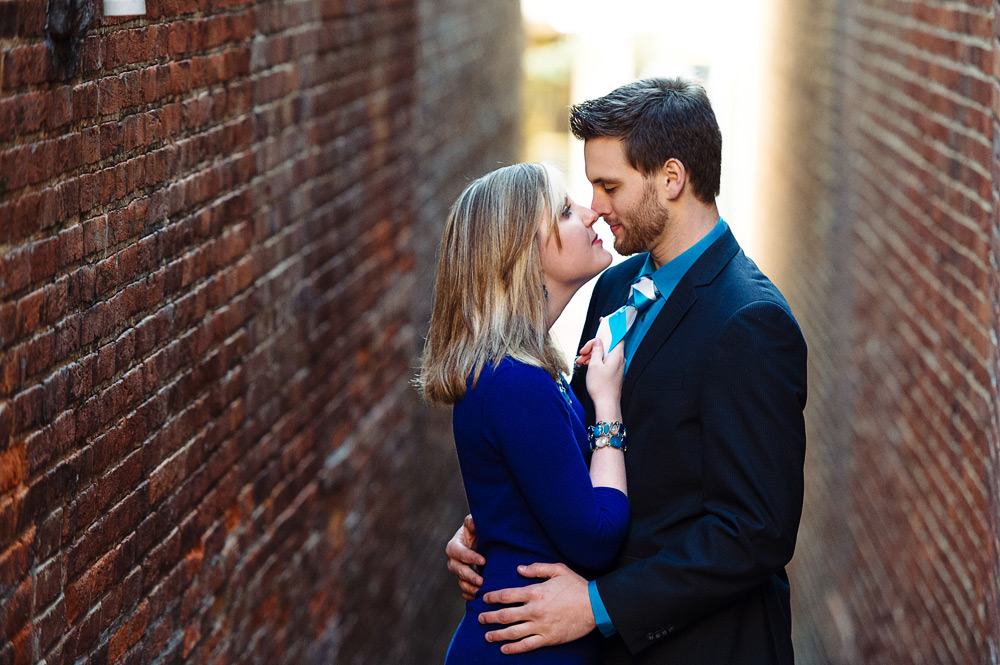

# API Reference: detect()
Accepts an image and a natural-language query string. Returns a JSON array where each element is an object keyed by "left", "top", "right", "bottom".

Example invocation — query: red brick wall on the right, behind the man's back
[{"left": 765, "top": 0, "right": 1000, "bottom": 663}]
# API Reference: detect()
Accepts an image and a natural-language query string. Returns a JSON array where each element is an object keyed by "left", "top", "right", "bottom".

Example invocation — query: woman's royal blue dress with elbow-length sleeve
[{"left": 445, "top": 358, "right": 629, "bottom": 665}]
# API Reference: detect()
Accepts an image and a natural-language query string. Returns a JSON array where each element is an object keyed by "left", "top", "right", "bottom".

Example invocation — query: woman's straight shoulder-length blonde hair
[{"left": 416, "top": 163, "right": 566, "bottom": 404}]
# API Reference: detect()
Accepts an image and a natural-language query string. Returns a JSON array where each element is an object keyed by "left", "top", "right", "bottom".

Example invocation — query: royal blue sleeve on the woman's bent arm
[{"left": 484, "top": 366, "right": 629, "bottom": 570}]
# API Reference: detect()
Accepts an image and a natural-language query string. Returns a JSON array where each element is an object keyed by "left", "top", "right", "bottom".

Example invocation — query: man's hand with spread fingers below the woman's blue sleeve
[{"left": 479, "top": 563, "right": 597, "bottom": 654}]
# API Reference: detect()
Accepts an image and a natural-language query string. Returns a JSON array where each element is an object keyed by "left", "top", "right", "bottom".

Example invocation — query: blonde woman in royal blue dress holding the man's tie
[{"left": 418, "top": 164, "right": 629, "bottom": 665}]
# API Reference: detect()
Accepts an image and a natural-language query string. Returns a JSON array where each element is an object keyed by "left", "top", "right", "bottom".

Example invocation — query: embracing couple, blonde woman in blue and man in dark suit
[{"left": 419, "top": 79, "right": 806, "bottom": 665}]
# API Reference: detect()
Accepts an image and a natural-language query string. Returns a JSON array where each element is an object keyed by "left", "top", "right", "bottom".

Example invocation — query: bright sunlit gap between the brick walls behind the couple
[{"left": 521, "top": 0, "right": 771, "bottom": 368}]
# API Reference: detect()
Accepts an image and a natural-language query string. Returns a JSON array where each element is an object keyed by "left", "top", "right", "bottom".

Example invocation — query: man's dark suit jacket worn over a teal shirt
[{"left": 573, "top": 230, "right": 806, "bottom": 665}]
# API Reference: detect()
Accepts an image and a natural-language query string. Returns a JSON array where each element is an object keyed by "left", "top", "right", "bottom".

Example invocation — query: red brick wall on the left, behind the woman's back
[{"left": 0, "top": 0, "right": 520, "bottom": 664}]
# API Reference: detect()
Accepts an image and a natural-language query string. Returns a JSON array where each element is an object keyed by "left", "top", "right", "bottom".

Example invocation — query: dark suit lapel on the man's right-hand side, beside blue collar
[{"left": 622, "top": 229, "right": 740, "bottom": 406}]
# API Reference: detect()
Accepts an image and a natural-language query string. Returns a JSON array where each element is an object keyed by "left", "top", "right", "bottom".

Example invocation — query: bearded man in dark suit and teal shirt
[{"left": 447, "top": 79, "right": 806, "bottom": 665}]
